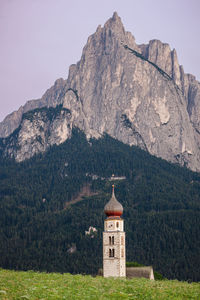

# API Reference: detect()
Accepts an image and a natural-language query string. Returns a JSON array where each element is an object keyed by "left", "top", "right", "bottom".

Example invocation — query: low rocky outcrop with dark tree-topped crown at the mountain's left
[{"left": 4, "top": 106, "right": 72, "bottom": 162}]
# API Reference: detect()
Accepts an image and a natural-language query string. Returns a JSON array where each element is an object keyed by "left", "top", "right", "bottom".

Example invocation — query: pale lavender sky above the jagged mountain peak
[{"left": 0, "top": 0, "right": 200, "bottom": 121}]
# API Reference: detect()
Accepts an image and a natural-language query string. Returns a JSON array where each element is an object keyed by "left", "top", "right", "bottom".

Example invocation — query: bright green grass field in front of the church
[{"left": 0, "top": 269, "right": 200, "bottom": 300}]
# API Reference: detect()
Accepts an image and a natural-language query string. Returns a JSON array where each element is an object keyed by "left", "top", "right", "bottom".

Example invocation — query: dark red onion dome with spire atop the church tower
[{"left": 104, "top": 185, "right": 123, "bottom": 217}]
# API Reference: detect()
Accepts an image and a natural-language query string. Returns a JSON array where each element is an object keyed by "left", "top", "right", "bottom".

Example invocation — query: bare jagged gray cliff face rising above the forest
[{"left": 1, "top": 13, "right": 200, "bottom": 170}]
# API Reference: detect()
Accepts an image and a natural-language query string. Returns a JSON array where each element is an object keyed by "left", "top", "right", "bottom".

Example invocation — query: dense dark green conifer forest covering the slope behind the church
[{"left": 0, "top": 129, "right": 200, "bottom": 281}]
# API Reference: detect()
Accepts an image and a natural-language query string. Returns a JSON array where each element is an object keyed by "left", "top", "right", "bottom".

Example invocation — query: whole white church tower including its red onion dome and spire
[{"left": 103, "top": 185, "right": 126, "bottom": 277}]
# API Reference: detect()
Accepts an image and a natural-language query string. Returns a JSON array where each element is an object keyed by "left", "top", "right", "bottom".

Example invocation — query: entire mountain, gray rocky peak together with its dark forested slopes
[{"left": 0, "top": 13, "right": 200, "bottom": 281}]
